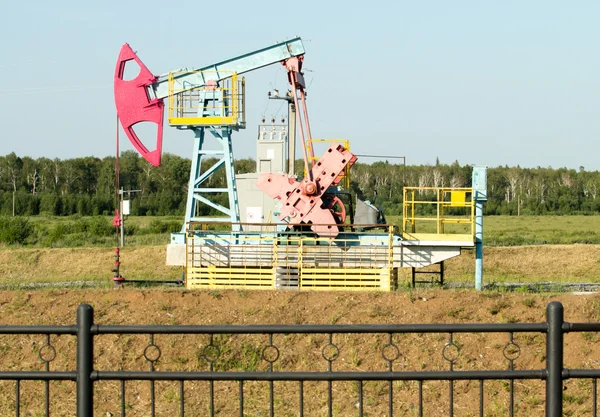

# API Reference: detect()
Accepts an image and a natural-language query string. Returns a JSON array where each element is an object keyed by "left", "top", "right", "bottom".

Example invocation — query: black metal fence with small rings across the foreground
[{"left": 0, "top": 302, "right": 600, "bottom": 417}]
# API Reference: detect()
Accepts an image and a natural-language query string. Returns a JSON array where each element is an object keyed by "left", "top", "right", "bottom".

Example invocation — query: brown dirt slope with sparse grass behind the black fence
[{"left": 0, "top": 288, "right": 600, "bottom": 416}]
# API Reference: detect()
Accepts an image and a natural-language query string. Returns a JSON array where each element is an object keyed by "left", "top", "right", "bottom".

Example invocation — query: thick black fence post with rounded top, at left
[{"left": 77, "top": 304, "right": 94, "bottom": 417}]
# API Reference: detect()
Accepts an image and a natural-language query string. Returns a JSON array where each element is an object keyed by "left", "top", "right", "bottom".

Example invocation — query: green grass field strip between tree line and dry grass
[{"left": 0, "top": 216, "right": 600, "bottom": 249}]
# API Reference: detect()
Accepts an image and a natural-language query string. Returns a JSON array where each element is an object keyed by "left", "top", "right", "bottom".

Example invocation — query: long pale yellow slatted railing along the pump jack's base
[{"left": 186, "top": 226, "right": 397, "bottom": 291}]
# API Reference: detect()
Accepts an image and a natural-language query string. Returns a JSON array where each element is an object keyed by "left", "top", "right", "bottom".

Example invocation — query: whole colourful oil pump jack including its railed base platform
[{"left": 114, "top": 38, "right": 474, "bottom": 291}]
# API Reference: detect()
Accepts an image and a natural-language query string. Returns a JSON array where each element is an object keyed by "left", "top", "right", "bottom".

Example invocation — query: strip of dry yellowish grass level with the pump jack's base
[{"left": 0, "top": 245, "right": 600, "bottom": 286}]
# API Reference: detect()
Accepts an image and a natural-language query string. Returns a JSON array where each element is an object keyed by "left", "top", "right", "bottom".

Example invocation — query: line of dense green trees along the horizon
[{"left": 0, "top": 151, "right": 600, "bottom": 216}]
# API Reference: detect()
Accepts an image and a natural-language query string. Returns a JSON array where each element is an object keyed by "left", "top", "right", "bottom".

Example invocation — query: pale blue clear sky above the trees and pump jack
[{"left": 0, "top": 0, "right": 600, "bottom": 170}]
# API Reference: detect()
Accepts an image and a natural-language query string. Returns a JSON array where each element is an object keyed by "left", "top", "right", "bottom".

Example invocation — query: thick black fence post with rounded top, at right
[{"left": 546, "top": 301, "right": 564, "bottom": 417}]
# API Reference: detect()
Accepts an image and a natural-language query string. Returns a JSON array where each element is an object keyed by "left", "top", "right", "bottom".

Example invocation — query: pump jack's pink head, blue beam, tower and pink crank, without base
[{"left": 114, "top": 38, "right": 356, "bottom": 243}]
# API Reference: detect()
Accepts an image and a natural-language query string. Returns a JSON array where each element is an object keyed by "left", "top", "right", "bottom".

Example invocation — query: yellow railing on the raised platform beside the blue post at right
[{"left": 402, "top": 187, "right": 475, "bottom": 240}]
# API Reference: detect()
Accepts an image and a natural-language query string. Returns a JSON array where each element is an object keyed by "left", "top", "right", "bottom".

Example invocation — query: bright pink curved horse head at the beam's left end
[{"left": 114, "top": 44, "right": 164, "bottom": 166}]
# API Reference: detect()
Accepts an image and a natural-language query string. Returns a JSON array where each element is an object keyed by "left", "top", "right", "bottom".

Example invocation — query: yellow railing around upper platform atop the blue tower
[{"left": 167, "top": 71, "right": 246, "bottom": 127}]
